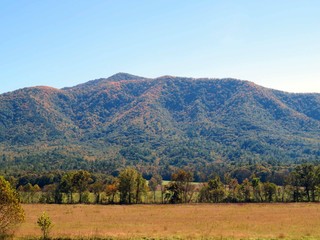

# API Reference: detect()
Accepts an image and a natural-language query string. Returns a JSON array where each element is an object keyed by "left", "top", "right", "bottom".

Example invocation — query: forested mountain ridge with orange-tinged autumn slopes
[{"left": 0, "top": 73, "right": 320, "bottom": 175}]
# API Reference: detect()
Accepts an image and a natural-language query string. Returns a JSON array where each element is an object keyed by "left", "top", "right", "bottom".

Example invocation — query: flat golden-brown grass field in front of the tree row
[{"left": 16, "top": 203, "right": 320, "bottom": 239}]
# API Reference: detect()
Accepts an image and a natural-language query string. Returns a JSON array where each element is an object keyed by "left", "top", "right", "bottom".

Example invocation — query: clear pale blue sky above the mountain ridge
[{"left": 0, "top": 0, "right": 320, "bottom": 93}]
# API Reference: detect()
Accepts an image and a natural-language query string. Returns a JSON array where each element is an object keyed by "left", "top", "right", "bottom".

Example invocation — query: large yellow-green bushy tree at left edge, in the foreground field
[{"left": 0, "top": 176, "right": 24, "bottom": 236}]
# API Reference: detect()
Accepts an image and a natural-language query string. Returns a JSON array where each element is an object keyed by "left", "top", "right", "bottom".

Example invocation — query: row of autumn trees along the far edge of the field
[{"left": 1, "top": 164, "right": 320, "bottom": 204}]
